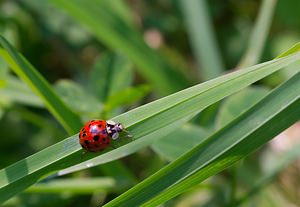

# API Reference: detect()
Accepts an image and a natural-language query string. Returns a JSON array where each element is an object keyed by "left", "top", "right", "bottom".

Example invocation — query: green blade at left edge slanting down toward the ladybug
[{"left": 0, "top": 35, "right": 81, "bottom": 134}]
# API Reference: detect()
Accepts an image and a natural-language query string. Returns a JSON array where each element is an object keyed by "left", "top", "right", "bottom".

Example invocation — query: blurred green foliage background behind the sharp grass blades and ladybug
[{"left": 0, "top": 0, "right": 300, "bottom": 206}]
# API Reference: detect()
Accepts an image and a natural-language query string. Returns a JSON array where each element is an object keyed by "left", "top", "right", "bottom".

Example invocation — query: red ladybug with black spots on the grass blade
[{"left": 79, "top": 120, "right": 124, "bottom": 152}]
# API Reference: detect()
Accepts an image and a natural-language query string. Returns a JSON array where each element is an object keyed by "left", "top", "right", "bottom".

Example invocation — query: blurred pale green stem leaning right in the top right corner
[{"left": 238, "top": 0, "right": 277, "bottom": 68}]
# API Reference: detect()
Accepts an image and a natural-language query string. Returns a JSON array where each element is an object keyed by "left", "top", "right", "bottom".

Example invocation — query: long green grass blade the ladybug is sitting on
[{"left": 0, "top": 53, "right": 300, "bottom": 202}]
